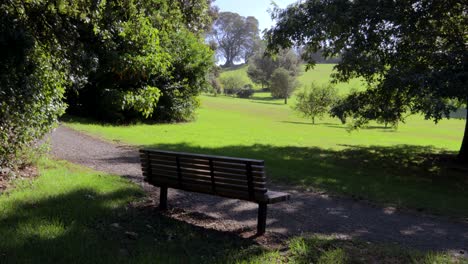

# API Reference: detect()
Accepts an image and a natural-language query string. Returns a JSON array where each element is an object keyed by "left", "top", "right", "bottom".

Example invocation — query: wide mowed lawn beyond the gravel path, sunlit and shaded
[{"left": 66, "top": 94, "right": 468, "bottom": 216}]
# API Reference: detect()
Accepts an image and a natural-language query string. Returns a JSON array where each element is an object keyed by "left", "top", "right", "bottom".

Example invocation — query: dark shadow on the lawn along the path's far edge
[{"left": 144, "top": 143, "right": 468, "bottom": 216}]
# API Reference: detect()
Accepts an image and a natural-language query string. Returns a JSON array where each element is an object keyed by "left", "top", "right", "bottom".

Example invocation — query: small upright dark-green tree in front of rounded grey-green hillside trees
[{"left": 270, "top": 68, "right": 298, "bottom": 104}]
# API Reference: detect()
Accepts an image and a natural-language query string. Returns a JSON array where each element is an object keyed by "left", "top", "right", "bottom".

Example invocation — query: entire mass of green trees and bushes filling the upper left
[{"left": 0, "top": 0, "right": 215, "bottom": 167}]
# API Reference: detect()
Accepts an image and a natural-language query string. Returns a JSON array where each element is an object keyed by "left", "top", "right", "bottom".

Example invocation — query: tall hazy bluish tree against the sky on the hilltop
[{"left": 209, "top": 12, "right": 259, "bottom": 67}]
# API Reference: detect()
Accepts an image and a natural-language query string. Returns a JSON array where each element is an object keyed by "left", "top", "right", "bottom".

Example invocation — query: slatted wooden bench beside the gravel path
[{"left": 140, "top": 149, "right": 290, "bottom": 235}]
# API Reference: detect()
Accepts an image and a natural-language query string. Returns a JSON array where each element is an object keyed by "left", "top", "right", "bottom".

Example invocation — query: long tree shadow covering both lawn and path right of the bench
[{"left": 137, "top": 143, "right": 468, "bottom": 250}]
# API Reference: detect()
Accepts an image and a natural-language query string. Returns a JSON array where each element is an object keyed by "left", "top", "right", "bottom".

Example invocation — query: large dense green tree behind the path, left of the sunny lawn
[{"left": 65, "top": 1, "right": 213, "bottom": 122}]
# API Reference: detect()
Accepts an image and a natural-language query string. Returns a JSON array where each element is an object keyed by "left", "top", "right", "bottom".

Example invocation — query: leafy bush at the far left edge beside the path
[{"left": 0, "top": 10, "right": 67, "bottom": 169}]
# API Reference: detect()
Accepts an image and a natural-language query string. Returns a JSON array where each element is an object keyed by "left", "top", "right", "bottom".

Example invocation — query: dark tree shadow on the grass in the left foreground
[{"left": 0, "top": 188, "right": 262, "bottom": 263}]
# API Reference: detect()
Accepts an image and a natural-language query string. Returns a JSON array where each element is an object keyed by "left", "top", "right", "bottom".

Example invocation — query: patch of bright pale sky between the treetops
[{"left": 214, "top": 0, "right": 297, "bottom": 32}]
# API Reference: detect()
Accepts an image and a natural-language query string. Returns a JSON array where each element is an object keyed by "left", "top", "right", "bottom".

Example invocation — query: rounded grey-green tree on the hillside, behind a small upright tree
[{"left": 247, "top": 48, "right": 301, "bottom": 88}]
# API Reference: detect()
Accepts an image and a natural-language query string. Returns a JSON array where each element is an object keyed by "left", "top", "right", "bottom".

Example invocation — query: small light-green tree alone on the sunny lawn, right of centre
[{"left": 293, "top": 83, "right": 338, "bottom": 124}]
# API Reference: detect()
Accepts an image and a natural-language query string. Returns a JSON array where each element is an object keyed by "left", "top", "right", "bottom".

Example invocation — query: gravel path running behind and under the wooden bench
[{"left": 50, "top": 126, "right": 468, "bottom": 256}]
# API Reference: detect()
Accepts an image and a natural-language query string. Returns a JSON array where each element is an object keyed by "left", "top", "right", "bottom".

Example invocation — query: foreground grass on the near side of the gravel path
[{"left": 0, "top": 159, "right": 466, "bottom": 264}]
